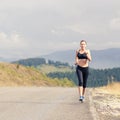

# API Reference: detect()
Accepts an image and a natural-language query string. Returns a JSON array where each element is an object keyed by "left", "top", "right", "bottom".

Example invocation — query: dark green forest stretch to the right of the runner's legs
[{"left": 88, "top": 68, "right": 120, "bottom": 87}]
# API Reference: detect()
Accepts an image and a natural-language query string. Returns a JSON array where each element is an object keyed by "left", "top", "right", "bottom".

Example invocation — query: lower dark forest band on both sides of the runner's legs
[{"left": 47, "top": 68, "right": 120, "bottom": 87}]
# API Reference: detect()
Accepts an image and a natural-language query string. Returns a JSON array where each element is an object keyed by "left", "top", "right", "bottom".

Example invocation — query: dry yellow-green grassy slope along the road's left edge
[{"left": 0, "top": 63, "right": 74, "bottom": 86}]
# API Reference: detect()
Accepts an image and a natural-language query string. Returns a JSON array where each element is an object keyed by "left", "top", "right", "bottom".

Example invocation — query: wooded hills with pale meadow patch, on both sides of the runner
[{"left": 10, "top": 58, "right": 120, "bottom": 87}]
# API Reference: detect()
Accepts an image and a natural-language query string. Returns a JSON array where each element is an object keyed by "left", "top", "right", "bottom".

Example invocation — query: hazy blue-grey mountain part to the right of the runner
[{"left": 91, "top": 48, "right": 120, "bottom": 68}]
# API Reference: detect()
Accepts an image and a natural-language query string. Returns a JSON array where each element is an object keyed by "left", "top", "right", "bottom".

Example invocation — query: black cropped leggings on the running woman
[{"left": 76, "top": 66, "right": 89, "bottom": 88}]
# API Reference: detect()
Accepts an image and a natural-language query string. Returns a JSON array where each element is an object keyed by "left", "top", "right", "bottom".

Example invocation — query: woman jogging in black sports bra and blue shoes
[{"left": 75, "top": 40, "right": 91, "bottom": 101}]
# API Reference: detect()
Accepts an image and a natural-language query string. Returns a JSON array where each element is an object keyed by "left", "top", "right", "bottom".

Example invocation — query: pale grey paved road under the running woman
[{"left": 0, "top": 87, "right": 95, "bottom": 120}]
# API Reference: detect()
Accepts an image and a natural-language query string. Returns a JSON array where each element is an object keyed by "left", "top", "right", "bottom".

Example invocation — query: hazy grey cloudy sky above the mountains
[{"left": 0, "top": 0, "right": 120, "bottom": 58}]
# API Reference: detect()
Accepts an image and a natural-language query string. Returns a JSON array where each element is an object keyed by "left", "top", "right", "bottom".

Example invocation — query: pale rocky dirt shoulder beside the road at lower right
[{"left": 92, "top": 88, "right": 120, "bottom": 120}]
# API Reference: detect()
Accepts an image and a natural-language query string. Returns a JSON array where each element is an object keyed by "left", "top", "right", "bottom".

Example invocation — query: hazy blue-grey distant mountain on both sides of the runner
[{"left": 42, "top": 48, "right": 120, "bottom": 69}]
